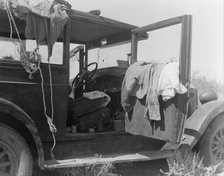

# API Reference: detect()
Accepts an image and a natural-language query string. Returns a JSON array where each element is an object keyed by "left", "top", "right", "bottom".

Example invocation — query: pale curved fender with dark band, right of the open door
[{"left": 181, "top": 100, "right": 224, "bottom": 148}]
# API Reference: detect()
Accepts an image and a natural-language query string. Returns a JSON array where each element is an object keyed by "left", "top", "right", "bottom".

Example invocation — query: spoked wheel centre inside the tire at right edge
[{"left": 210, "top": 129, "right": 224, "bottom": 163}]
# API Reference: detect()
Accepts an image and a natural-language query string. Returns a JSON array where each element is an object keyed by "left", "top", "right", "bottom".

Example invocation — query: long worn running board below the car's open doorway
[{"left": 44, "top": 151, "right": 174, "bottom": 169}]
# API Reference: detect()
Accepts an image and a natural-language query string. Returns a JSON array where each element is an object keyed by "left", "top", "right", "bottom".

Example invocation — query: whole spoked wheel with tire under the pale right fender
[{"left": 199, "top": 113, "right": 224, "bottom": 166}]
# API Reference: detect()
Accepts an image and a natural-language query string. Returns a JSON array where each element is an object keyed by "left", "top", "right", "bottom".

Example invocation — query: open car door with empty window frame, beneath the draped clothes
[{"left": 125, "top": 15, "right": 192, "bottom": 144}]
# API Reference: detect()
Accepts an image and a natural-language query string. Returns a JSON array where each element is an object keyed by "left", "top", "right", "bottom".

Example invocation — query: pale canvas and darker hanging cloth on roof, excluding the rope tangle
[{"left": 0, "top": 0, "right": 71, "bottom": 57}]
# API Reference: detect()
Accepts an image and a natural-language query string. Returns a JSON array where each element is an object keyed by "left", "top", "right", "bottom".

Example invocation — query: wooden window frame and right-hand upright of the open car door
[{"left": 131, "top": 15, "right": 192, "bottom": 143}]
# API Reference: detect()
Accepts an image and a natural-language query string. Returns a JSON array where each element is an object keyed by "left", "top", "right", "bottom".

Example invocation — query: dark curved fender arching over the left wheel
[{"left": 0, "top": 98, "right": 44, "bottom": 168}]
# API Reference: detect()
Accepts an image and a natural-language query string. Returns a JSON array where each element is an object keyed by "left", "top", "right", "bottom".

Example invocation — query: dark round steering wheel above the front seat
[{"left": 71, "top": 62, "right": 98, "bottom": 89}]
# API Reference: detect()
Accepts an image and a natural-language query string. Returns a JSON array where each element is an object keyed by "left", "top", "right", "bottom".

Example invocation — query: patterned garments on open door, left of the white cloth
[{"left": 121, "top": 62, "right": 164, "bottom": 120}]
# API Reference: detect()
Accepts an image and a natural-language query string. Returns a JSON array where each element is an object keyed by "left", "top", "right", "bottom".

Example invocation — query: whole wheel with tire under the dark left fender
[{"left": 0, "top": 123, "right": 33, "bottom": 176}]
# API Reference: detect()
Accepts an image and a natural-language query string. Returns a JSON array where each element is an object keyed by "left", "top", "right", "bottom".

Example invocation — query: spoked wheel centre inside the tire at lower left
[{"left": 0, "top": 140, "right": 18, "bottom": 176}]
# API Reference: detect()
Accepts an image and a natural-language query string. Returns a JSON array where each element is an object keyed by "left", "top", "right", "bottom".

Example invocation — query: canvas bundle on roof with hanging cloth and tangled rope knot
[{"left": 0, "top": 0, "right": 71, "bottom": 79}]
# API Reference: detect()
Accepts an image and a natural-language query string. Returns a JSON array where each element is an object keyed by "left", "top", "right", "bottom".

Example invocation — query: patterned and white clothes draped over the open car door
[{"left": 121, "top": 62, "right": 187, "bottom": 121}]
